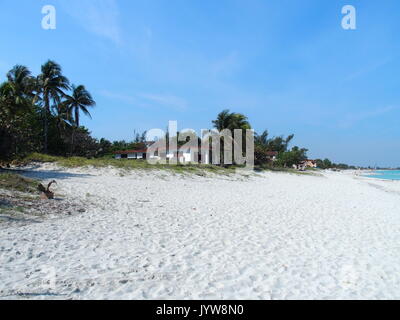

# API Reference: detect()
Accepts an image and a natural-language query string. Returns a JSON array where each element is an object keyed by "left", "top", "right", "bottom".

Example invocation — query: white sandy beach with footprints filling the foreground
[{"left": 0, "top": 165, "right": 400, "bottom": 299}]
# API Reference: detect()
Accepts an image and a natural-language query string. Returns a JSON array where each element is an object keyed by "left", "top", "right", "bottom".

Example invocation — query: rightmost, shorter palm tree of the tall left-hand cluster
[{"left": 63, "top": 85, "right": 96, "bottom": 153}]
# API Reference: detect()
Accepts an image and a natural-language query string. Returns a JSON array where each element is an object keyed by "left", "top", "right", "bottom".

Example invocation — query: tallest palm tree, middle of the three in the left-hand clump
[{"left": 37, "top": 60, "right": 69, "bottom": 153}]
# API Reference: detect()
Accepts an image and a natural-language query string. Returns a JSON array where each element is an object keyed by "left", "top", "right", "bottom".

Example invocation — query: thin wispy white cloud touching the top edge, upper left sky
[{"left": 61, "top": 0, "right": 122, "bottom": 45}]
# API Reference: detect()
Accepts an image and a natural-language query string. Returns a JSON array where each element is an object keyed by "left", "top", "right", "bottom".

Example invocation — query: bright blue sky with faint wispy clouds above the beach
[{"left": 0, "top": 0, "right": 400, "bottom": 167}]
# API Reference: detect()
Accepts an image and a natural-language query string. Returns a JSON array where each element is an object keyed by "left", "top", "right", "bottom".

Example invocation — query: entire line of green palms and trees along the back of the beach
[{"left": 0, "top": 60, "right": 351, "bottom": 169}]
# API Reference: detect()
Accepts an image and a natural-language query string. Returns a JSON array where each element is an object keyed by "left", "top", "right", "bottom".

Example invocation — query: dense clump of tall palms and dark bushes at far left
[{"left": 0, "top": 60, "right": 97, "bottom": 159}]
